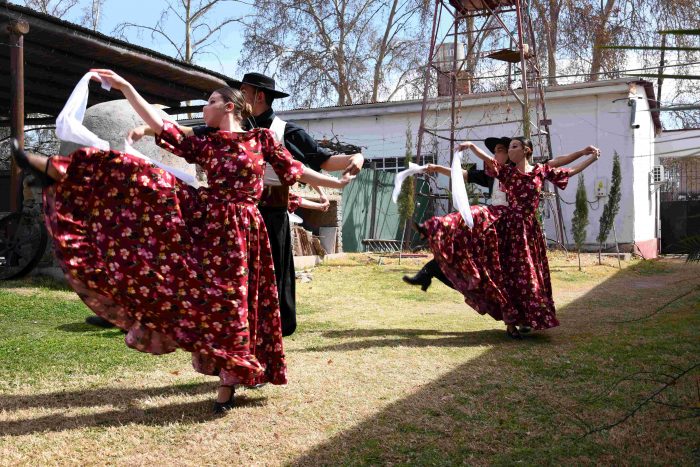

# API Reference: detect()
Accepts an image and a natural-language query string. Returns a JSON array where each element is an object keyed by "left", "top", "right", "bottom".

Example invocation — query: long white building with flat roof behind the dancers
[{"left": 279, "top": 79, "right": 660, "bottom": 258}]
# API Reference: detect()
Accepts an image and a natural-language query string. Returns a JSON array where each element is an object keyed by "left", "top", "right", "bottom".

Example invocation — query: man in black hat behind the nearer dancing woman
[{"left": 223, "top": 73, "right": 364, "bottom": 336}]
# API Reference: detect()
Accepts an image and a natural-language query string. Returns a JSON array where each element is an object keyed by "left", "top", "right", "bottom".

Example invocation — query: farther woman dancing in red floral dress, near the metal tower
[{"left": 418, "top": 138, "right": 600, "bottom": 338}]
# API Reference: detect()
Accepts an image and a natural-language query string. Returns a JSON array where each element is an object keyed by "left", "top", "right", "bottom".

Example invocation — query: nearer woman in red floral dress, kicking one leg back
[{"left": 14, "top": 70, "right": 352, "bottom": 412}]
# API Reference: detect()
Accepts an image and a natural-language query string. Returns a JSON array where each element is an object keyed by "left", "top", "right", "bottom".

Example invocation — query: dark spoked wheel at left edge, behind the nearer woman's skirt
[{"left": 0, "top": 212, "right": 48, "bottom": 280}]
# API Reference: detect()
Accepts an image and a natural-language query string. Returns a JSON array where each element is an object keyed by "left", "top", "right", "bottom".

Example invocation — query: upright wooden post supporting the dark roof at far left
[{"left": 7, "top": 20, "right": 29, "bottom": 211}]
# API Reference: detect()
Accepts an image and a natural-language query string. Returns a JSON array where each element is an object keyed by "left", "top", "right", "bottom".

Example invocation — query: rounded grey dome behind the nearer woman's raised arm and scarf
[{"left": 60, "top": 99, "right": 196, "bottom": 182}]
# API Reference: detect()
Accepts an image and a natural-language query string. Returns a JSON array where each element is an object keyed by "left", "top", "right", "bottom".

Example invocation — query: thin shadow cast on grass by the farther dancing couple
[{"left": 301, "top": 329, "right": 549, "bottom": 352}]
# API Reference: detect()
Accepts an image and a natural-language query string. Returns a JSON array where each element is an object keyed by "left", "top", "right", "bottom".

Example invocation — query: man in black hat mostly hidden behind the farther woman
[{"left": 403, "top": 136, "right": 510, "bottom": 292}]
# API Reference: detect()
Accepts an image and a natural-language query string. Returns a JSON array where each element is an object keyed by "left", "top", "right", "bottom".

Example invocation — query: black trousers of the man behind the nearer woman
[{"left": 260, "top": 207, "right": 297, "bottom": 336}]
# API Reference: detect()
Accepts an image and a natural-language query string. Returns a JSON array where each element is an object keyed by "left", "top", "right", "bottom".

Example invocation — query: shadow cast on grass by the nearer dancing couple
[{"left": 0, "top": 382, "right": 265, "bottom": 436}]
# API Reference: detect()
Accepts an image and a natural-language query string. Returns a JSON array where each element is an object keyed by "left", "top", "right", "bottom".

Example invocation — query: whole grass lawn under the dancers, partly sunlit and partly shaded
[{"left": 0, "top": 255, "right": 700, "bottom": 465}]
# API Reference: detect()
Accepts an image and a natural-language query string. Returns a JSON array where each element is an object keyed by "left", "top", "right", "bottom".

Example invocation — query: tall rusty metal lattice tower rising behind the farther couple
[{"left": 416, "top": 0, "right": 565, "bottom": 246}]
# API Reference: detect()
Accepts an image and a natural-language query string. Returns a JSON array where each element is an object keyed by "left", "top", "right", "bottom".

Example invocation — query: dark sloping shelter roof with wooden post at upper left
[{"left": 0, "top": 0, "right": 237, "bottom": 210}]
